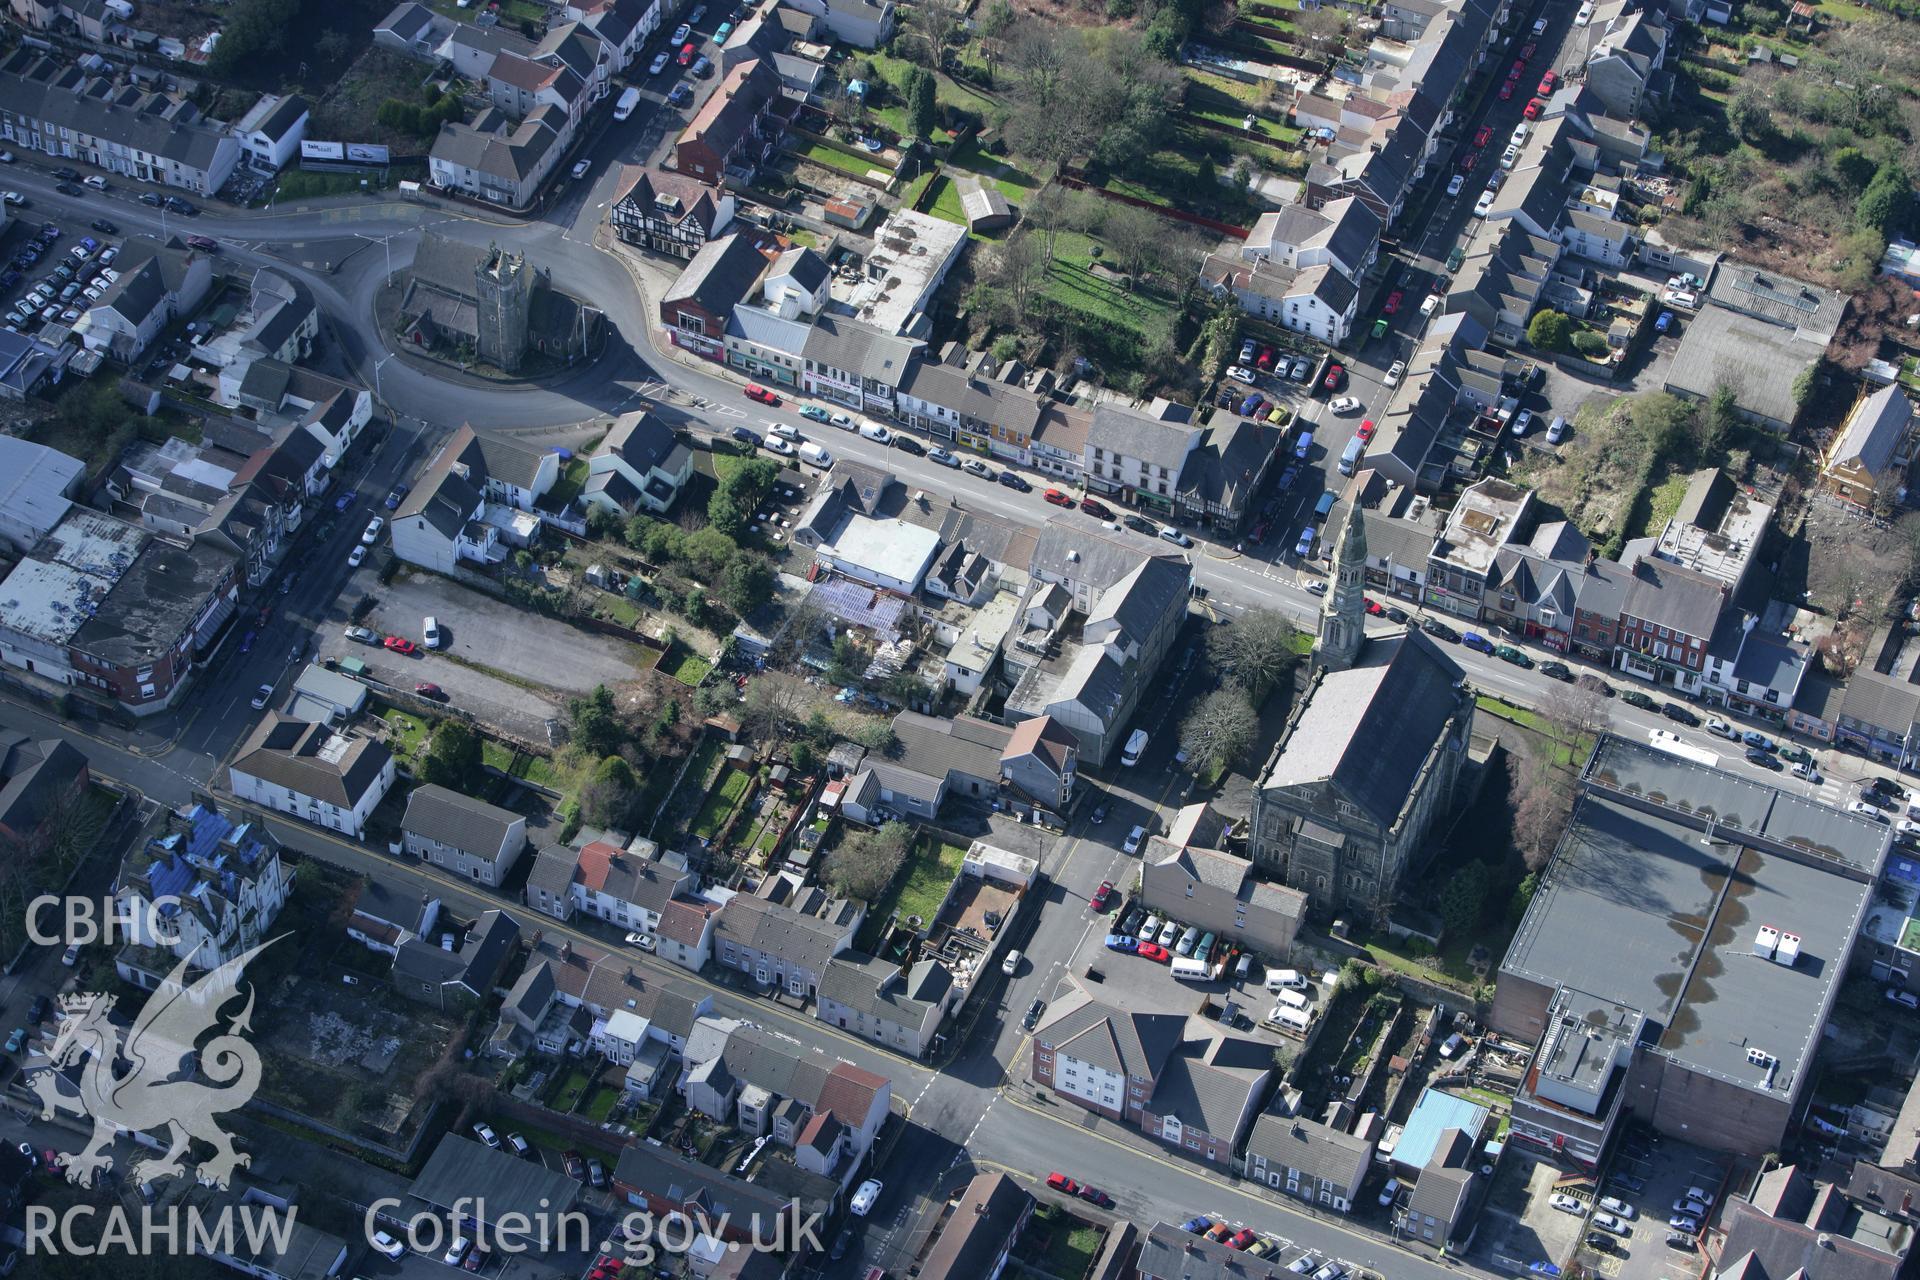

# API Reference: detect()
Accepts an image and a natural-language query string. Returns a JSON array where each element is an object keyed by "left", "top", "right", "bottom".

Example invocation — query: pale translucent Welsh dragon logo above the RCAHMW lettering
[{"left": 31, "top": 940, "right": 273, "bottom": 1188}]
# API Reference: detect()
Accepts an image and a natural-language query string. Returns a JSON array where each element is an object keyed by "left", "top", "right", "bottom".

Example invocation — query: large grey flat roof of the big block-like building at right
[{"left": 1501, "top": 739, "right": 1885, "bottom": 1098}]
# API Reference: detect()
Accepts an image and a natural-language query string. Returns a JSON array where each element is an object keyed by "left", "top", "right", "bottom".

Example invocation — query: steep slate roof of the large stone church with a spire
[{"left": 1261, "top": 631, "right": 1463, "bottom": 827}]
